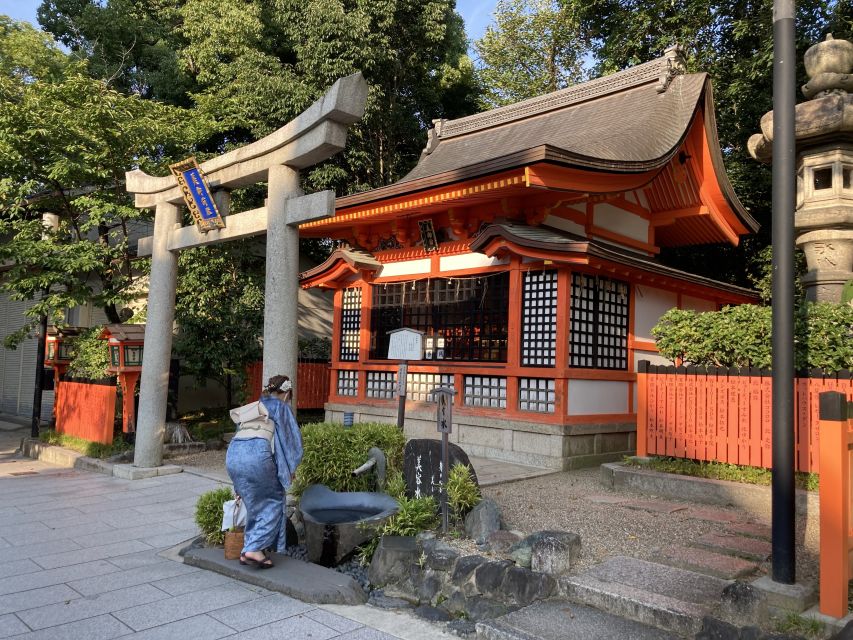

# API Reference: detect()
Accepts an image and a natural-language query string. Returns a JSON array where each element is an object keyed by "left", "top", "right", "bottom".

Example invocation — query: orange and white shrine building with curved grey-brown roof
[{"left": 300, "top": 48, "right": 758, "bottom": 469}]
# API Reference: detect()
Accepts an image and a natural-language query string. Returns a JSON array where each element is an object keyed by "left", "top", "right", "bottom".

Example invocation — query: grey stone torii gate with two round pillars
[{"left": 125, "top": 73, "right": 367, "bottom": 475}]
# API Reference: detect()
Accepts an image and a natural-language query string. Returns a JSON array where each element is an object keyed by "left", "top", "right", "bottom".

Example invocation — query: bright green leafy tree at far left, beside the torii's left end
[{"left": 0, "top": 17, "right": 212, "bottom": 346}]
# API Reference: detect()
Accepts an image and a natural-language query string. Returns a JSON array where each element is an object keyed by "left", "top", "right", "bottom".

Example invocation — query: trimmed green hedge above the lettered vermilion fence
[{"left": 652, "top": 302, "right": 853, "bottom": 371}]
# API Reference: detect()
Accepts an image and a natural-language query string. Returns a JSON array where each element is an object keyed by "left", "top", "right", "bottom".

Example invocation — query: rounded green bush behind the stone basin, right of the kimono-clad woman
[{"left": 292, "top": 423, "right": 406, "bottom": 495}]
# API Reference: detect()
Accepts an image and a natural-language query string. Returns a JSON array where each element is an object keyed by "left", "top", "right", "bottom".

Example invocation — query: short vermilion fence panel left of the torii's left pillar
[{"left": 54, "top": 381, "right": 116, "bottom": 444}]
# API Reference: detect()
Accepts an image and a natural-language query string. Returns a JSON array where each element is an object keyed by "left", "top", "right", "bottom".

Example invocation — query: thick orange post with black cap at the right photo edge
[{"left": 820, "top": 392, "right": 853, "bottom": 618}]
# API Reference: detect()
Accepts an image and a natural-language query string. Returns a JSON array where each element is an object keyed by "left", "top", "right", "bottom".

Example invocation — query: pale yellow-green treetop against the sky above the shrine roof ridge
[{"left": 474, "top": 0, "right": 586, "bottom": 107}]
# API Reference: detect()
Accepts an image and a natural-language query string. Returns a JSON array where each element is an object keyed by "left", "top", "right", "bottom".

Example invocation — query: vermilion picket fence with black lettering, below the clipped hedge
[{"left": 637, "top": 361, "right": 853, "bottom": 473}]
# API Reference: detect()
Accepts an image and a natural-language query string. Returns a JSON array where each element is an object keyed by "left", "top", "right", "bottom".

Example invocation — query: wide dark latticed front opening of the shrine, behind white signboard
[{"left": 370, "top": 272, "right": 509, "bottom": 362}]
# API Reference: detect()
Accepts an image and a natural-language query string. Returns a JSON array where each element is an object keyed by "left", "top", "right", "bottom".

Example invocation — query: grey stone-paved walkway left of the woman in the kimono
[{"left": 0, "top": 428, "right": 450, "bottom": 640}]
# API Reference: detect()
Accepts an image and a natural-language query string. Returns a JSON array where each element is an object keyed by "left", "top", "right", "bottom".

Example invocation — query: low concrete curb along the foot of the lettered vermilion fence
[{"left": 600, "top": 462, "right": 820, "bottom": 516}]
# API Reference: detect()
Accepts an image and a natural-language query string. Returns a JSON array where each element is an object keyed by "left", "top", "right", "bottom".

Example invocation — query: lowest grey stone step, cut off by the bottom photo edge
[{"left": 477, "top": 599, "right": 678, "bottom": 640}]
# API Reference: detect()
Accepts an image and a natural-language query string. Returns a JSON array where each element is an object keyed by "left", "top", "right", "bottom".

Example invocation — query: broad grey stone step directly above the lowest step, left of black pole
[{"left": 560, "top": 556, "right": 730, "bottom": 637}]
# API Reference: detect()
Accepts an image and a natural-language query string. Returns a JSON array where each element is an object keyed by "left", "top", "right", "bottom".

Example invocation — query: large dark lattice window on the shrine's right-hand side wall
[{"left": 569, "top": 273, "right": 629, "bottom": 370}]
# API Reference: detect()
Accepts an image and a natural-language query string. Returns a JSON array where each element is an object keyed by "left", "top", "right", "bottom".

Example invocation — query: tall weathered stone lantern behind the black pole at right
[{"left": 748, "top": 35, "right": 853, "bottom": 302}]
